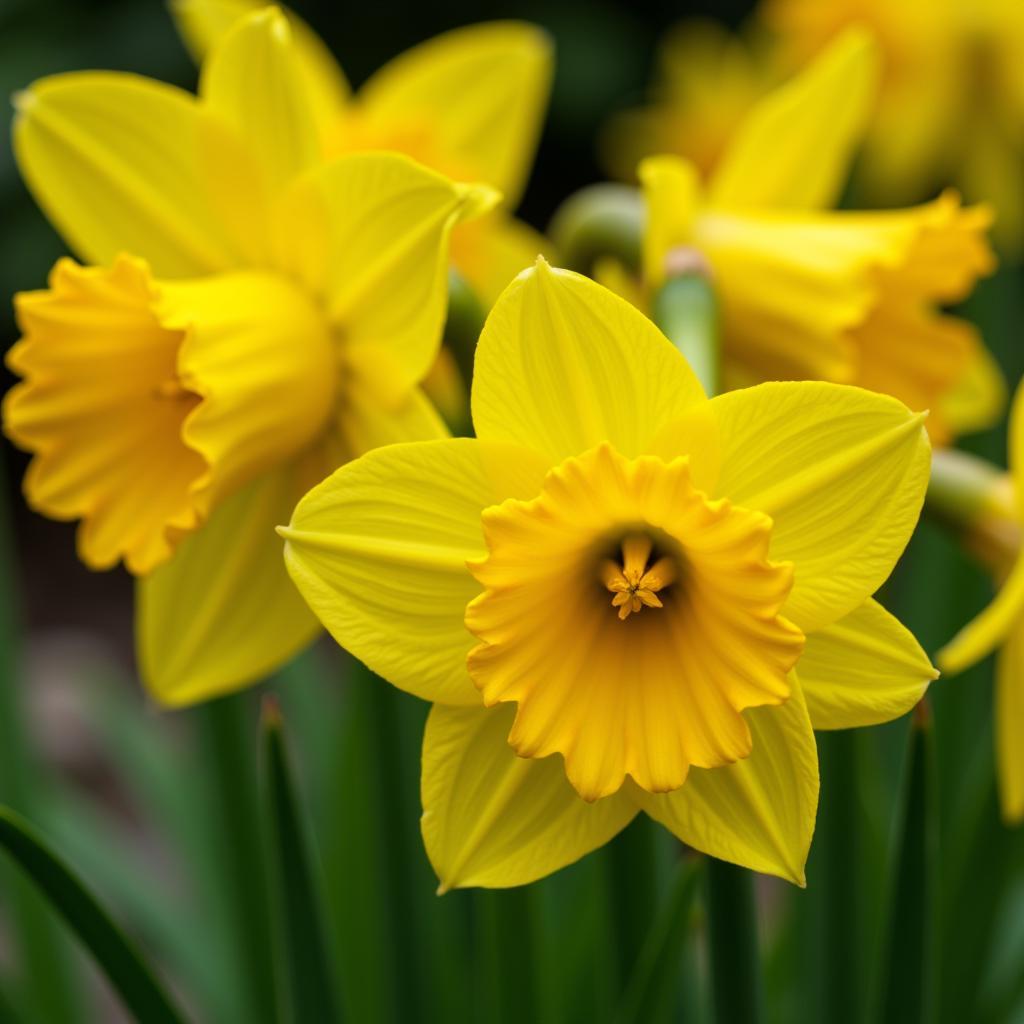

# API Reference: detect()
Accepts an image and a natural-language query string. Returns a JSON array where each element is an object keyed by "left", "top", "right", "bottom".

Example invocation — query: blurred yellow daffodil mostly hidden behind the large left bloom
[{"left": 171, "top": 0, "right": 552, "bottom": 306}]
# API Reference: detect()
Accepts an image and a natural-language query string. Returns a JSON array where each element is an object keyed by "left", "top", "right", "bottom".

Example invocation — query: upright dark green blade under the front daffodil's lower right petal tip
[{"left": 874, "top": 705, "right": 938, "bottom": 1024}]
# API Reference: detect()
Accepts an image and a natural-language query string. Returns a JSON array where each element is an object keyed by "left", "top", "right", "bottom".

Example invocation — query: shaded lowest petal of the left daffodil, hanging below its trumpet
[{"left": 135, "top": 464, "right": 322, "bottom": 707}]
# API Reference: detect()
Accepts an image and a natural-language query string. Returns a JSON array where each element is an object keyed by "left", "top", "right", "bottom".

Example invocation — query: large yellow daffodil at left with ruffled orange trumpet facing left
[{"left": 3, "top": 9, "right": 494, "bottom": 705}]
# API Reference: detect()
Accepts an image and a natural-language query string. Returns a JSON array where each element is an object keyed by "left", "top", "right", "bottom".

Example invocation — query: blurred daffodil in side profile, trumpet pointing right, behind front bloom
[{"left": 608, "top": 33, "right": 1004, "bottom": 441}]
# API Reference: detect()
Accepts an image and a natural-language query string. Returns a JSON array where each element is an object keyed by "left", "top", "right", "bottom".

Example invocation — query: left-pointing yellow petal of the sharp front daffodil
[{"left": 282, "top": 438, "right": 544, "bottom": 706}]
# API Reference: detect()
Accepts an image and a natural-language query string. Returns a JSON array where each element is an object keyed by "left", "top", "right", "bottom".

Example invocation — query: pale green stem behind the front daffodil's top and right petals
[{"left": 651, "top": 268, "right": 721, "bottom": 395}]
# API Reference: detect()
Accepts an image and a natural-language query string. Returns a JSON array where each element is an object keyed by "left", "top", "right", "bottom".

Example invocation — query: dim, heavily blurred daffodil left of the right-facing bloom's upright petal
[{"left": 600, "top": 18, "right": 776, "bottom": 181}]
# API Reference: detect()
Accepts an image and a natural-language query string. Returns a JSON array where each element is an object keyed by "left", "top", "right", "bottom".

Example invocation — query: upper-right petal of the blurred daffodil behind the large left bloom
[{"left": 358, "top": 22, "right": 553, "bottom": 208}]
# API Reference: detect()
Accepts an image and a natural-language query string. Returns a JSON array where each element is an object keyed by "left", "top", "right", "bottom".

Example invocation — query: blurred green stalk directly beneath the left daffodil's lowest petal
[{"left": 195, "top": 694, "right": 280, "bottom": 1024}]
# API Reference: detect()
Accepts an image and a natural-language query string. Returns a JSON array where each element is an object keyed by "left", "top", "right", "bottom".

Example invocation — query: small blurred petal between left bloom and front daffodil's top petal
[{"left": 452, "top": 210, "right": 552, "bottom": 309}]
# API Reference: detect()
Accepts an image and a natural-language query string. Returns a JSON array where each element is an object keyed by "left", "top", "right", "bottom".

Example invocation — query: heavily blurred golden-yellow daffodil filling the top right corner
[{"left": 763, "top": 0, "right": 1024, "bottom": 251}]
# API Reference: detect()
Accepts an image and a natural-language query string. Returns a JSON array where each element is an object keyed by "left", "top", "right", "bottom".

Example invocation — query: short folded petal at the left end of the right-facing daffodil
[{"left": 639, "top": 157, "right": 700, "bottom": 291}]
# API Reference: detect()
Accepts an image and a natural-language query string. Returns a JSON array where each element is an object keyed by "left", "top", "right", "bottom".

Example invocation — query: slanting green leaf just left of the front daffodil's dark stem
[{"left": 615, "top": 857, "right": 703, "bottom": 1024}]
